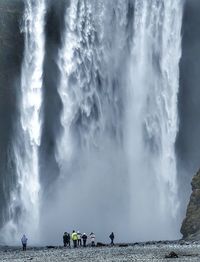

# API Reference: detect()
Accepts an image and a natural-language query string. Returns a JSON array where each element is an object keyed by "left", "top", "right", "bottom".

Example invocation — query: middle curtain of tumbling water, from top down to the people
[{"left": 43, "top": 0, "right": 131, "bottom": 243}]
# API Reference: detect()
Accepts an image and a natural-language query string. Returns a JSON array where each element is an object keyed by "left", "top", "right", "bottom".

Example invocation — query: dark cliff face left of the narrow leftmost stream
[{"left": 0, "top": 0, "right": 24, "bottom": 225}]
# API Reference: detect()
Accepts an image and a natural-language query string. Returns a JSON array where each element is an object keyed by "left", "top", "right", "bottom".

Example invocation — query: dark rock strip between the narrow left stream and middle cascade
[{"left": 40, "top": 0, "right": 66, "bottom": 196}]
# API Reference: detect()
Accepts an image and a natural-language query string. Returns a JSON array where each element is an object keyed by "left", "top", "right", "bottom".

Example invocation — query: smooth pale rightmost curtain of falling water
[{"left": 126, "top": 0, "right": 183, "bottom": 239}]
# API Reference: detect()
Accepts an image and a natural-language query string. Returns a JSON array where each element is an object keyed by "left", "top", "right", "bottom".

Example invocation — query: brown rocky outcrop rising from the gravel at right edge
[{"left": 181, "top": 170, "right": 200, "bottom": 240}]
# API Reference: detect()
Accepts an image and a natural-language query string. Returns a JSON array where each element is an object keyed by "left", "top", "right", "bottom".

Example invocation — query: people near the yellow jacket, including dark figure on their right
[{"left": 63, "top": 230, "right": 115, "bottom": 248}]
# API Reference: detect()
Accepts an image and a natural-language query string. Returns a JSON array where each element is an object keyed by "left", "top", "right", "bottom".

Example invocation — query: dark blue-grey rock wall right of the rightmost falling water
[{"left": 176, "top": 0, "right": 200, "bottom": 215}]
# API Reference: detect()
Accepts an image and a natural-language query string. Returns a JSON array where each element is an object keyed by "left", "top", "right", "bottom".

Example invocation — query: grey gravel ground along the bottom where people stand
[{"left": 0, "top": 244, "right": 200, "bottom": 262}]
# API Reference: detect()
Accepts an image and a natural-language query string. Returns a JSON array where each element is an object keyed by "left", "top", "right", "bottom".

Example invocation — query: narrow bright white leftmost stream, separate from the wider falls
[{"left": 1, "top": 0, "right": 45, "bottom": 243}]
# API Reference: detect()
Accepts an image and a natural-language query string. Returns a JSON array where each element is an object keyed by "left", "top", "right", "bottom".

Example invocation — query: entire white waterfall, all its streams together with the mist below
[{"left": 2, "top": 0, "right": 183, "bottom": 243}]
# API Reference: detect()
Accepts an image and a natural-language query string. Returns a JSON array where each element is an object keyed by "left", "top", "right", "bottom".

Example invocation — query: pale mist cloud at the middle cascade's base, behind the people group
[{"left": 41, "top": 141, "right": 131, "bottom": 244}]
